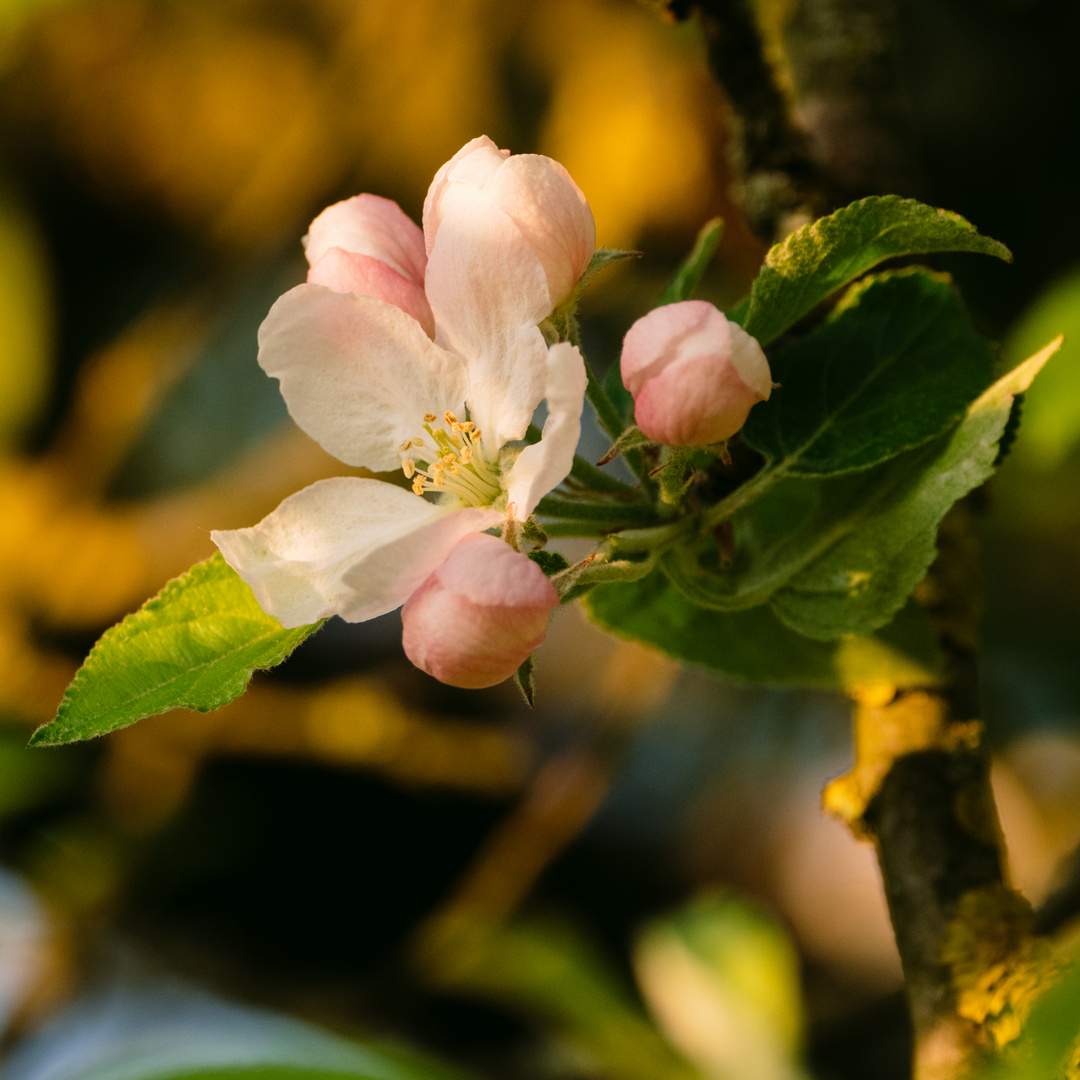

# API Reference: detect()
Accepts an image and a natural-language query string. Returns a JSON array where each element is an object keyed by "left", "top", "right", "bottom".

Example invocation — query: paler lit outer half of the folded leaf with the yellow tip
[{"left": 771, "top": 338, "right": 1061, "bottom": 640}]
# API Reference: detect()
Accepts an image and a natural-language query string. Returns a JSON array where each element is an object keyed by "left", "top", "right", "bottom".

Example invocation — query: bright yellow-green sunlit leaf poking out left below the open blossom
[{"left": 30, "top": 554, "right": 322, "bottom": 746}]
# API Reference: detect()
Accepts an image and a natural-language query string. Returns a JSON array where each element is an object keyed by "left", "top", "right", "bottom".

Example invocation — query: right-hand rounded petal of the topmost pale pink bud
[{"left": 485, "top": 153, "right": 596, "bottom": 306}]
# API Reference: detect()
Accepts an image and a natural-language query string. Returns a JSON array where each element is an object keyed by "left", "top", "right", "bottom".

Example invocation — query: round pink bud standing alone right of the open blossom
[{"left": 622, "top": 300, "right": 772, "bottom": 446}]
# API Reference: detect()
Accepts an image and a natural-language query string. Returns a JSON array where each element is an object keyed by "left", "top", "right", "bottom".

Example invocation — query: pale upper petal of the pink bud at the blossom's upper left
[{"left": 303, "top": 194, "right": 428, "bottom": 288}]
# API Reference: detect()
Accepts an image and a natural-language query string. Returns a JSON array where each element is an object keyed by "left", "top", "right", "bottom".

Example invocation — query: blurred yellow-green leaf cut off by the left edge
[{"left": 0, "top": 187, "right": 52, "bottom": 447}]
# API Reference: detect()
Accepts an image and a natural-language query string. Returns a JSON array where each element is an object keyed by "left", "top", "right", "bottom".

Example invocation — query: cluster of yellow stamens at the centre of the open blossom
[{"left": 397, "top": 413, "right": 502, "bottom": 507}]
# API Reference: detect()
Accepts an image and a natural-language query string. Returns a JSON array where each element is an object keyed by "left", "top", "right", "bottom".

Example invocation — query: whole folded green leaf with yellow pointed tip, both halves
[{"left": 661, "top": 336, "right": 1054, "bottom": 640}]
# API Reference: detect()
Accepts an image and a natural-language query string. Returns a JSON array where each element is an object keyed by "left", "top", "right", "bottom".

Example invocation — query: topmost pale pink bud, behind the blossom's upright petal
[{"left": 423, "top": 136, "right": 596, "bottom": 308}]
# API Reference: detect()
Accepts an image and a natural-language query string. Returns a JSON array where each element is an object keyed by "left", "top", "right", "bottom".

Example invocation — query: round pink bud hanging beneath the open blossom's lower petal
[{"left": 402, "top": 532, "right": 558, "bottom": 690}]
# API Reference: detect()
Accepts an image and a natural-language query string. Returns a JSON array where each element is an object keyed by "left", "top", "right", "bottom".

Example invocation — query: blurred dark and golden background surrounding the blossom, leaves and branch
[{"left": 0, "top": 0, "right": 1080, "bottom": 1080}]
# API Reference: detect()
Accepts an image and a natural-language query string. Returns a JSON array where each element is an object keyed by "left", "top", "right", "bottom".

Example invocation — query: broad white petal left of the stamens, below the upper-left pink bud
[{"left": 259, "top": 285, "right": 468, "bottom": 470}]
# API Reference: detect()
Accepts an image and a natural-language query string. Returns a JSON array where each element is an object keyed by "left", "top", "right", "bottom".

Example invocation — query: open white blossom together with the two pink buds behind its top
[{"left": 212, "top": 138, "right": 593, "bottom": 626}]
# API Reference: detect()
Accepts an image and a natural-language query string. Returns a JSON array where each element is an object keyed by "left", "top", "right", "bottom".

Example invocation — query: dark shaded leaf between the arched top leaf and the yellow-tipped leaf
[{"left": 743, "top": 270, "right": 993, "bottom": 476}]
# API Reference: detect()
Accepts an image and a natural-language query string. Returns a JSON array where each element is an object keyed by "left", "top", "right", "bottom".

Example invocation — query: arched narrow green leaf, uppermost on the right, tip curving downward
[{"left": 743, "top": 195, "right": 1012, "bottom": 345}]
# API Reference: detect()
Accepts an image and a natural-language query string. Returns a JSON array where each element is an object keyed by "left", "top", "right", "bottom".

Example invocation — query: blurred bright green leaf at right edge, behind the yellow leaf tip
[{"left": 1002, "top": 270, "right": 1080, "bottom": 469}]
